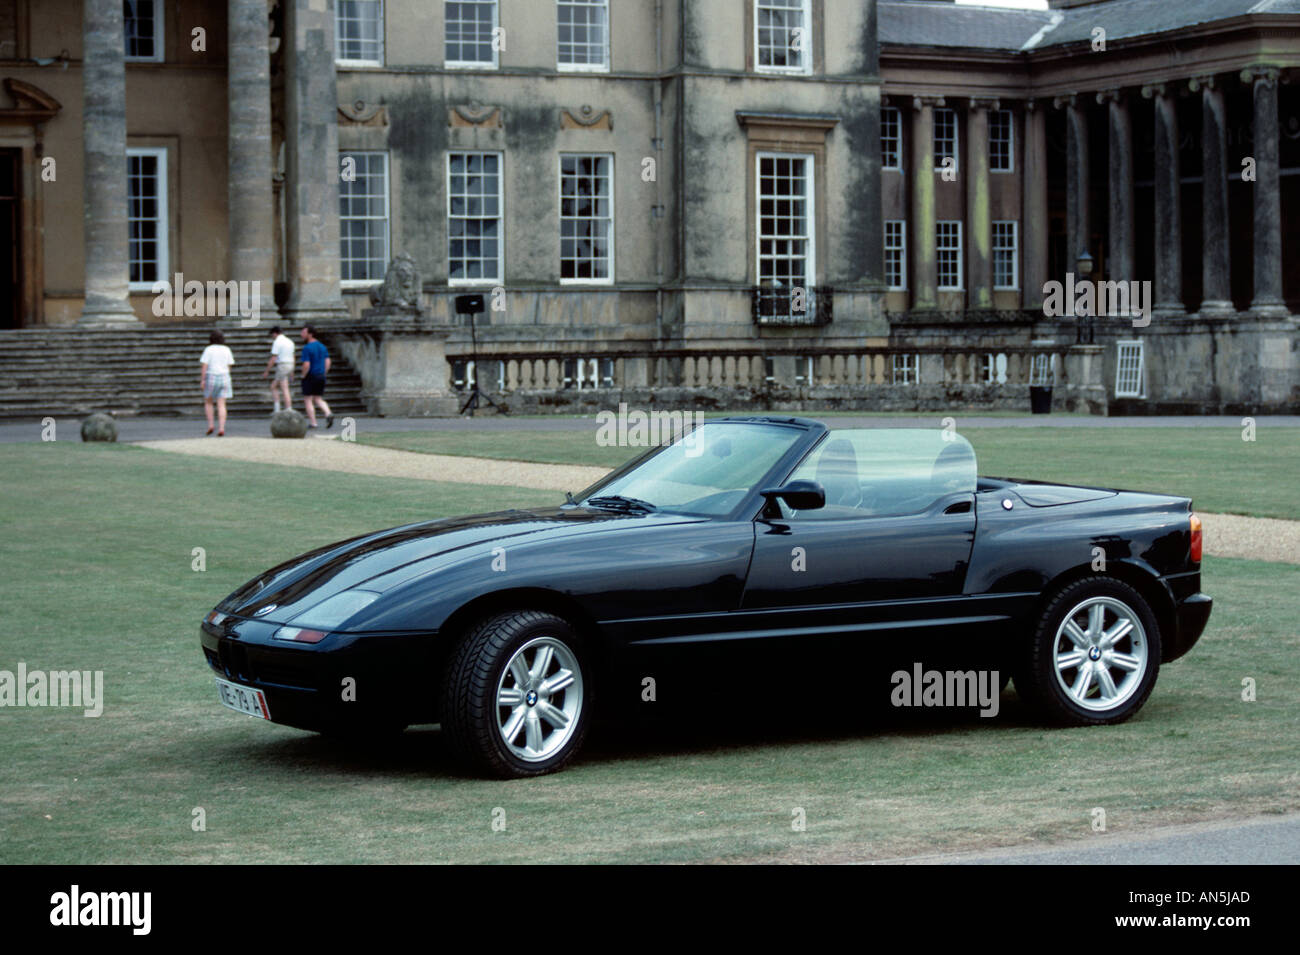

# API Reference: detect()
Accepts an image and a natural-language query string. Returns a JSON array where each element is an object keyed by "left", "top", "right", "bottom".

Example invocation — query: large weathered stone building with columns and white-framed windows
[{"left": 0, "top": 0, "right": 1300, "bottom": 412}]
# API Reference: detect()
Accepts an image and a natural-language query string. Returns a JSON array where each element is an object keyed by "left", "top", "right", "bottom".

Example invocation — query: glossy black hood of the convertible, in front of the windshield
[{"left": 217, "top": 507, "right": 698, "bottom": 624}]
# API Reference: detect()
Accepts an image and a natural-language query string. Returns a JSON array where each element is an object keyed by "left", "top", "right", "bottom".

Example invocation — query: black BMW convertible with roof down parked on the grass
[{"left": 202, "top": 417, "right": 1212, "bottom": 776}]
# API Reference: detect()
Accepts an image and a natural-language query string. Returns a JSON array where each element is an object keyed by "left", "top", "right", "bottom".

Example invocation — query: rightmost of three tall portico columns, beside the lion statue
[{"left": 282, "top": 0, "right": 348, "bottom": 322}]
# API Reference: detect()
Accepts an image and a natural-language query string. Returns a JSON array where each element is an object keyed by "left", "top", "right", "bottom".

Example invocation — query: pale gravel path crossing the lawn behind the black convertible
[{"left": 139, "top": 437, "right": 1300, "bottom": 564}]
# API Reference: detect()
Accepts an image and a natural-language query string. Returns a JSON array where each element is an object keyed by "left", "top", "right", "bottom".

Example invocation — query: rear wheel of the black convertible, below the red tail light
[{"left": 1014, "top": 577, "right": 1161, "bottom": 726}]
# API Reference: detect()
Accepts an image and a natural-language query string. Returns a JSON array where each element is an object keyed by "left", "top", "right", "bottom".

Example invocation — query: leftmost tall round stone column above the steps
[{"left": 81, "top": 0, "right": 139, "bottom": 326}]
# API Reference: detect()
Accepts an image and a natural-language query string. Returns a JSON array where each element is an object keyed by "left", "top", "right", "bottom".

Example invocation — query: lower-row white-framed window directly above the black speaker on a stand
[{"left": 447, "top": 152, "right": 503, "bottom": 285}]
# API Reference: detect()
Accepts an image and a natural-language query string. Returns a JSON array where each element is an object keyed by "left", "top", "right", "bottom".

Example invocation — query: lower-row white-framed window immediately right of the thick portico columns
[{"left": 338, "top": 152, "right": 389, "bottom": 283}]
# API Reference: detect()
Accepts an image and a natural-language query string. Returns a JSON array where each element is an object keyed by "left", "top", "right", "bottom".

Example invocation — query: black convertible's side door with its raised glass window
[{"left": 740, "top": 429, "right": 979, "bottom": 641}]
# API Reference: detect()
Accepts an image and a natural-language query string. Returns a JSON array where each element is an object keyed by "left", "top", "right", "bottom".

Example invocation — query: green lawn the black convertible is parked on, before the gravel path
[{"left": 0, "top": 444, "right": 1300, "bottom": 863}]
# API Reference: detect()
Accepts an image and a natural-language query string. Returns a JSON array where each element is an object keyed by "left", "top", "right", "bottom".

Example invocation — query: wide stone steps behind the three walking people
[{"left": 0, "top": 326, "right": 365, "bottom": 420}]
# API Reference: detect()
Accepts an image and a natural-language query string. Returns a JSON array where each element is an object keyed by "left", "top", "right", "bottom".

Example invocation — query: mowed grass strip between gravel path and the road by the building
[{"left": 358, "top": 414, "right": 1300, "bottom": 520}]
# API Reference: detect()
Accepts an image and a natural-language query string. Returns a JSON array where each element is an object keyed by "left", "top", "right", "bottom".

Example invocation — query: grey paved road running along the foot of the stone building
[{"left": 0, "top": 412, "right": 1300, "bottom": 443}]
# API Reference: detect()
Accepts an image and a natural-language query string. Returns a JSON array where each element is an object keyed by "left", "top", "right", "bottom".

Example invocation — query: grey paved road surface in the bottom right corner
[{"left": 881, "top": 815, "right": 1300, "bottom": 865}]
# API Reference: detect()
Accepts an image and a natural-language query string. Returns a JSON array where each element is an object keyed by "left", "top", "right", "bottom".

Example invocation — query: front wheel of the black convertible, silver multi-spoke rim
[{"left": 439, "top": 611, "right": 594, "bottom": 778}]
